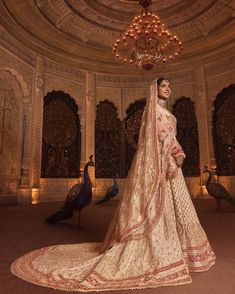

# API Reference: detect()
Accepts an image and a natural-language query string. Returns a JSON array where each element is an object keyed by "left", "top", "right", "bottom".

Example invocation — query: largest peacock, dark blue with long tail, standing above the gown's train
[{"left": 46, "top": 155, "right": 94, "bottom": 227}]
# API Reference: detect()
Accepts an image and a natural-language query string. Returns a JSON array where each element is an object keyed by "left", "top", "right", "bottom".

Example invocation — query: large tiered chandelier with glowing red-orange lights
[{"left": 113, "top": 0, "right": 183, "bottom": 70}]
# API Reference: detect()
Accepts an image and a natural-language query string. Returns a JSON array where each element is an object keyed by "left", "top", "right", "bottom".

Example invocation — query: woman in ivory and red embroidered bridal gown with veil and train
[{"left": 11, "top": 78, "right": 215, "bottom": 292}]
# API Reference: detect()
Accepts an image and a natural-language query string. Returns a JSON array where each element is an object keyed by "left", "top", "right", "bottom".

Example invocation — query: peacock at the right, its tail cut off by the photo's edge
[{"left": 203, "top": 166, "right": 235, "bottom": 210}]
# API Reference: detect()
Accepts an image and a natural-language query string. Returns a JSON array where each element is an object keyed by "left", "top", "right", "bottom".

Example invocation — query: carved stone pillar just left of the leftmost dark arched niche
[{"left": 31, "top": 56, "right": 45, "bottom": 200}]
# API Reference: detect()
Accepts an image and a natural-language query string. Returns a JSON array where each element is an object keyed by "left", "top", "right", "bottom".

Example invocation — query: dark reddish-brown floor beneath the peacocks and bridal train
[{"left": 0, "top": 199, "right": 235, "bottom": 294}]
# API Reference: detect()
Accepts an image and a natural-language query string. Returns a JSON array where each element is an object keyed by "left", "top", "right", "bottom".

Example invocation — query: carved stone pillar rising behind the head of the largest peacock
[{"left": 85, "top": 72, "right": 96, "bottom": 185}]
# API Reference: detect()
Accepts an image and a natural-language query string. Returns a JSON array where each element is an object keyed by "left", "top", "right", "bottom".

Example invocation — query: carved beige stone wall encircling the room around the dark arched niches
[{"left": 0, "top": 38, "right": 235, "bottom": 202}]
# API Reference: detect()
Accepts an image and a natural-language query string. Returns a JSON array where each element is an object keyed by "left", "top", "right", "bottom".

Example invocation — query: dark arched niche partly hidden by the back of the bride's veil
[{"left": 125, "top": 98, "right": 146, "bottom": 176}]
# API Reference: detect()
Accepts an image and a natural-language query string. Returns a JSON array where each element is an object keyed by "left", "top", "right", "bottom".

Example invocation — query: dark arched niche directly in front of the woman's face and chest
[{"left": 173, "top": 97, "right": 200, "bottom": 177}]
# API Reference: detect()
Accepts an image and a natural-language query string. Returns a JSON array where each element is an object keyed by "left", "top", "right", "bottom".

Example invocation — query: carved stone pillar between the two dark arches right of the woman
[{"left": 195, "top": 67, "right": 211, "bottom": 169}]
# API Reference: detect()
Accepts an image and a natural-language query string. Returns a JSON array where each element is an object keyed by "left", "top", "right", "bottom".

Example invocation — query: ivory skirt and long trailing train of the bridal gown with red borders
[{"left": 11, "top": 165, "right": 215, "bottom": 291}]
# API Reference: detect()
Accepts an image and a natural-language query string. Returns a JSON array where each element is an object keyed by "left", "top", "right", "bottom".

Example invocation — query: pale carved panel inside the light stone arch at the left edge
[{"left": 0, "top": 71, "right": 24, "bottom": 193}]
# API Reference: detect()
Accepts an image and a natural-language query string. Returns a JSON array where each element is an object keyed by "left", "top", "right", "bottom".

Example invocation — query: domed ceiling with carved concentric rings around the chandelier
[{"left": 0, "top": 0, "right": 235, "bottom": 74}]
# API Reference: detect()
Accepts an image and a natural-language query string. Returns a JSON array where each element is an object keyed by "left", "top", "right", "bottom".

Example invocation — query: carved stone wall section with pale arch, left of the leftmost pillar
[{"left": 0, "top": 47, "right": 34, "bottom": 203}]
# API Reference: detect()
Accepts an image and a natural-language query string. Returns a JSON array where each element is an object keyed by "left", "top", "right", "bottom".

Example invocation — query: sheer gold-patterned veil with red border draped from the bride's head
[{"left": 103, "top": 79, "right": 173, "bottom": 250}]
